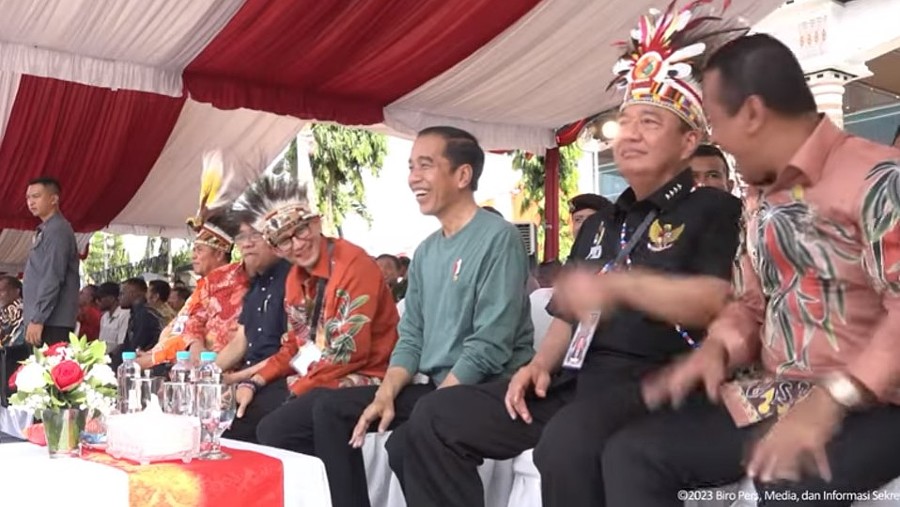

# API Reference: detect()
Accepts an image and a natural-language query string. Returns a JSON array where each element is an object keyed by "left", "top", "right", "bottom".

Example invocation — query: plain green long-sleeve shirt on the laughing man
[{"left": 391, "top": 209, "right": 534, "bottom": 384}]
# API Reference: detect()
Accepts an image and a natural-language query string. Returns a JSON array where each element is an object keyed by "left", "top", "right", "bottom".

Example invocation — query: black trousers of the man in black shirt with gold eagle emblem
[{"left": 396, "top": 359, "right": 656, "bottom": 507}]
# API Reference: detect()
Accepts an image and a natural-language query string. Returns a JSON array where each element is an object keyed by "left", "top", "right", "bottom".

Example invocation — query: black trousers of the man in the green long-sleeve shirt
[{"left": 256, "top": 385, "right": 434, "bottom": 507}]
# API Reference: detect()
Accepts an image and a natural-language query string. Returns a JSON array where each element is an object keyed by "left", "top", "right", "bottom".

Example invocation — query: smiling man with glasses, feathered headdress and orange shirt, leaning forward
[{"left": 219, "top": 174, "right": 399, "bottom": 444}]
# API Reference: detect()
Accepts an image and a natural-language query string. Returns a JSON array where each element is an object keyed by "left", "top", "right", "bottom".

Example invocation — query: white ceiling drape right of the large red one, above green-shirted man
[{"left": 385, "top": 0, "right": 783, "bottom": 153}]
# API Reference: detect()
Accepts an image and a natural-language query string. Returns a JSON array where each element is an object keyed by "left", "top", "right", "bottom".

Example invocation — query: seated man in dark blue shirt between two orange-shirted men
[{"left": 217, "top": 220, "right": 291, "bottom": 442}]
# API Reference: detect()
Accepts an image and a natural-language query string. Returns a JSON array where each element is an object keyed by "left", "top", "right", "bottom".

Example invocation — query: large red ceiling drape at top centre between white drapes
[{"left": 184, "top": 0, "right": 540, "bottom": 125}]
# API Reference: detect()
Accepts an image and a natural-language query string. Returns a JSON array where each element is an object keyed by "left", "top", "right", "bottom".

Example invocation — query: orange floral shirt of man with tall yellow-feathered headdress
[{"left": 153, "top": 264, "right": 250, "bottom": 365}]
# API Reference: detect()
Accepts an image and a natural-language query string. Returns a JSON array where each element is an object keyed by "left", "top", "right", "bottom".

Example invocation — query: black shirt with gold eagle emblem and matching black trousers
[{"left": 396, "top": 169, "right": 741, "bottom": 507}]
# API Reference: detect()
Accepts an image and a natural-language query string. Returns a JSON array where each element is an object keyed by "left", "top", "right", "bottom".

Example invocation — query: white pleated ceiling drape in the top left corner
[{"left": 0, "top": 0, "right": 244, "bottom": 96}]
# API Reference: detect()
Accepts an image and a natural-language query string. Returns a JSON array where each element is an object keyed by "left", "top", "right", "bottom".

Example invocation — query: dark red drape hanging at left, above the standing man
[{"left": 0, "top": 76, "right": 184, "bottom": 232}]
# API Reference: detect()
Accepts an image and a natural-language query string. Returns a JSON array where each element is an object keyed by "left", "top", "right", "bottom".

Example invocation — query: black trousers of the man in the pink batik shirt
[{"left": 602, "top": 400, "right": 900, "bottom": 507}]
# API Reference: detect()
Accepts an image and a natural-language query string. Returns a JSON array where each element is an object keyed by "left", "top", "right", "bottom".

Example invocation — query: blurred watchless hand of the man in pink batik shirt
[{"left": 641, "top": 340, "right": 728, "bottom": 409}]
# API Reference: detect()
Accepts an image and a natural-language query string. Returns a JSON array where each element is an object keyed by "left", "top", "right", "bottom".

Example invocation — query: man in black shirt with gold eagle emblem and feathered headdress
[{"left": 388, "top": 0, "right": 741, "bottom": 507}]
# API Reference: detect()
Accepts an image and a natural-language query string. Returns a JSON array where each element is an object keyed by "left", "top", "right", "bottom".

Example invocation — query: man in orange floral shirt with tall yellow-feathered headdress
[{"left": 138, "top": 151, "right": 249, "bottom": 369}]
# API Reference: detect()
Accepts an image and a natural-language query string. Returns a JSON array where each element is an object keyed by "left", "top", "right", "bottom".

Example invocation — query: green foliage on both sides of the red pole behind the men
[{"left": 513, "top": 144, "right": 582, "bottom": 260}]
